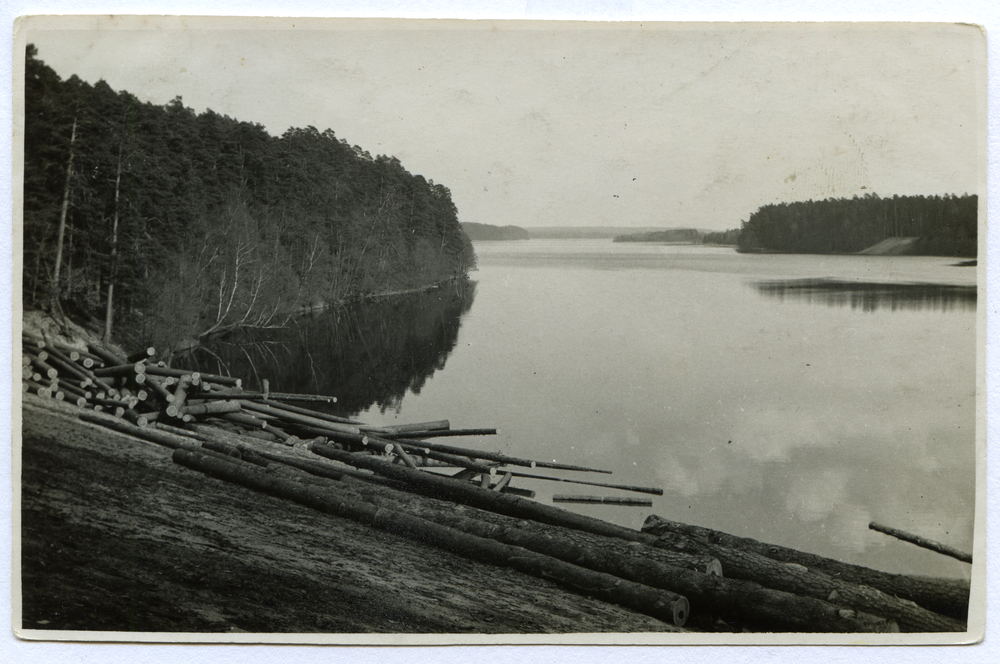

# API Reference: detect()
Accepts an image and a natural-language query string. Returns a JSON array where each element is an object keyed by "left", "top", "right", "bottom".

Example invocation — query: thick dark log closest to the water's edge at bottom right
[{"left": 642, "top": 514, "right": 970, "bottom": 620}]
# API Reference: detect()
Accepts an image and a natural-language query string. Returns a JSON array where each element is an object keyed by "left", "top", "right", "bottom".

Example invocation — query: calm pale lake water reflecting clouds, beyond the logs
[{"left": 201, "top": 240, "right": 976, "bottom": 576}]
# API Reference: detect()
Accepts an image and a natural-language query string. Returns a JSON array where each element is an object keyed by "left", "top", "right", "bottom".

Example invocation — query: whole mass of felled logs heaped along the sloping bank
[{"left": 23, "top": 335, "right": 969, "bottom": 632}]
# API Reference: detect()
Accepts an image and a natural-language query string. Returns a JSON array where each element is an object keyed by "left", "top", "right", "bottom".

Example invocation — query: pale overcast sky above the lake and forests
[{"left": 21, "top": 19, "right": 985, "bottom": 230}]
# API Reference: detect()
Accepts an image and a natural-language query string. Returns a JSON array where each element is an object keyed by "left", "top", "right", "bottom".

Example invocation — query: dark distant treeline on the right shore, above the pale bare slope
[{"left": 738, "top": 194, "right": 978, "bottom": 258}]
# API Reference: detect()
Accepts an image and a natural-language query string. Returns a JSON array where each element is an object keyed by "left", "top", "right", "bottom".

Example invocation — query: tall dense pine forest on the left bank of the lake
[{"left": 23, "top": 45, "right": 475, "bottom": 356}]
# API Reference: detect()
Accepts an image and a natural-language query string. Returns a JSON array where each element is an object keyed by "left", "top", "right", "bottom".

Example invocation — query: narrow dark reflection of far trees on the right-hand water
[{"left": 753, "top": 279, "right": 976, "bottom": 311}]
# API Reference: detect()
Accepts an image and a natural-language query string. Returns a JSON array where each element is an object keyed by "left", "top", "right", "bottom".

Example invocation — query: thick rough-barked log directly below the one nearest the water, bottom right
[{"left": 656, "top": 533, "right": 966, "bottom": 632}]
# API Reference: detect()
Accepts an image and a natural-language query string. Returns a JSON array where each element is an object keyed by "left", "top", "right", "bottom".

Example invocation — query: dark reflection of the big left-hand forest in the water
[{"left": 178, "top": 279, "right": 476, "bottom": 415}]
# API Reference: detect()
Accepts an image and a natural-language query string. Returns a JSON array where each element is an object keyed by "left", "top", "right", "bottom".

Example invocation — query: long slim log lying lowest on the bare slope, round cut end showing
[{"left": 173, "top": 450, "right": 690, "bottom": 626}]
